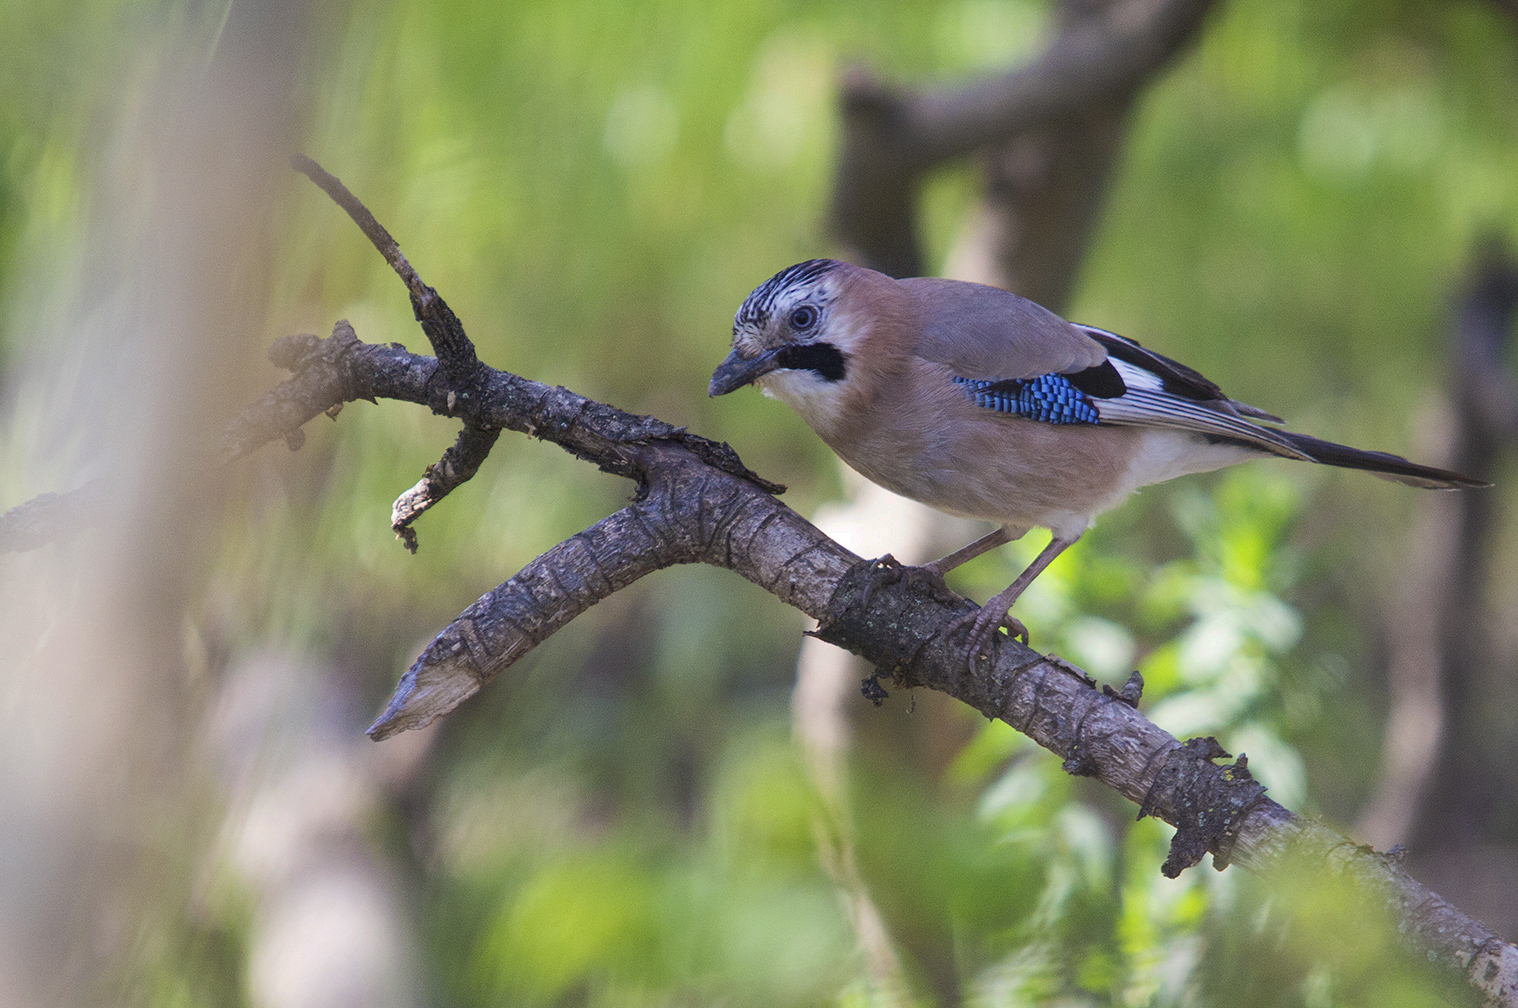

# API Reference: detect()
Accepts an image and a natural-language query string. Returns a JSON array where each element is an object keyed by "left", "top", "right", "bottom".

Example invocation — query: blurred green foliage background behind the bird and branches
[{"left": 0, "top": 0, "right": 1518, "bottom": 1006}]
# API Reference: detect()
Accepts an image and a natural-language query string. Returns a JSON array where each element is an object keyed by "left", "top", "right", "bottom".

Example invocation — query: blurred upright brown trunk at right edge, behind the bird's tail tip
[{"left": 1360, "top": 241, "right": 1518, "bottom": 850}]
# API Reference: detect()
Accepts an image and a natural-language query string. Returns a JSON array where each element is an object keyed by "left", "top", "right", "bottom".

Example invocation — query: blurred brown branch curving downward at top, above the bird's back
[{"left": 832, "top": 0, "right": 1211, "bottom": 277}]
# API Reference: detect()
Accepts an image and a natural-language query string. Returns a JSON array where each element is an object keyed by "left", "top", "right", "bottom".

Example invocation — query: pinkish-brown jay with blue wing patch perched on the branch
[{"left": 707, "top": 260, "right": 1489, "bottom": 662}]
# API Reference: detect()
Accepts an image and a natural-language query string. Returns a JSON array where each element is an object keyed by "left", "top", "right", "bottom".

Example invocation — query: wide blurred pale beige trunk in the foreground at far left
[{"left": 0, "top": 0, "right": 338, "bottom": 1005}]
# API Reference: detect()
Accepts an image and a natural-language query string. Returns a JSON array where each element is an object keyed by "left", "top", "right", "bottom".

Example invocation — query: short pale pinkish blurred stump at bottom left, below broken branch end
[{"left": 211, "top": 651, "right": 436, "bottom": 1008}]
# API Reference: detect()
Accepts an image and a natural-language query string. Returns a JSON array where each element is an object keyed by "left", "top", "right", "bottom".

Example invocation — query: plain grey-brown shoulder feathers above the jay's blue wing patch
[{"left": 899, "top": 276, "right": 1107, "bottom": 381}]
